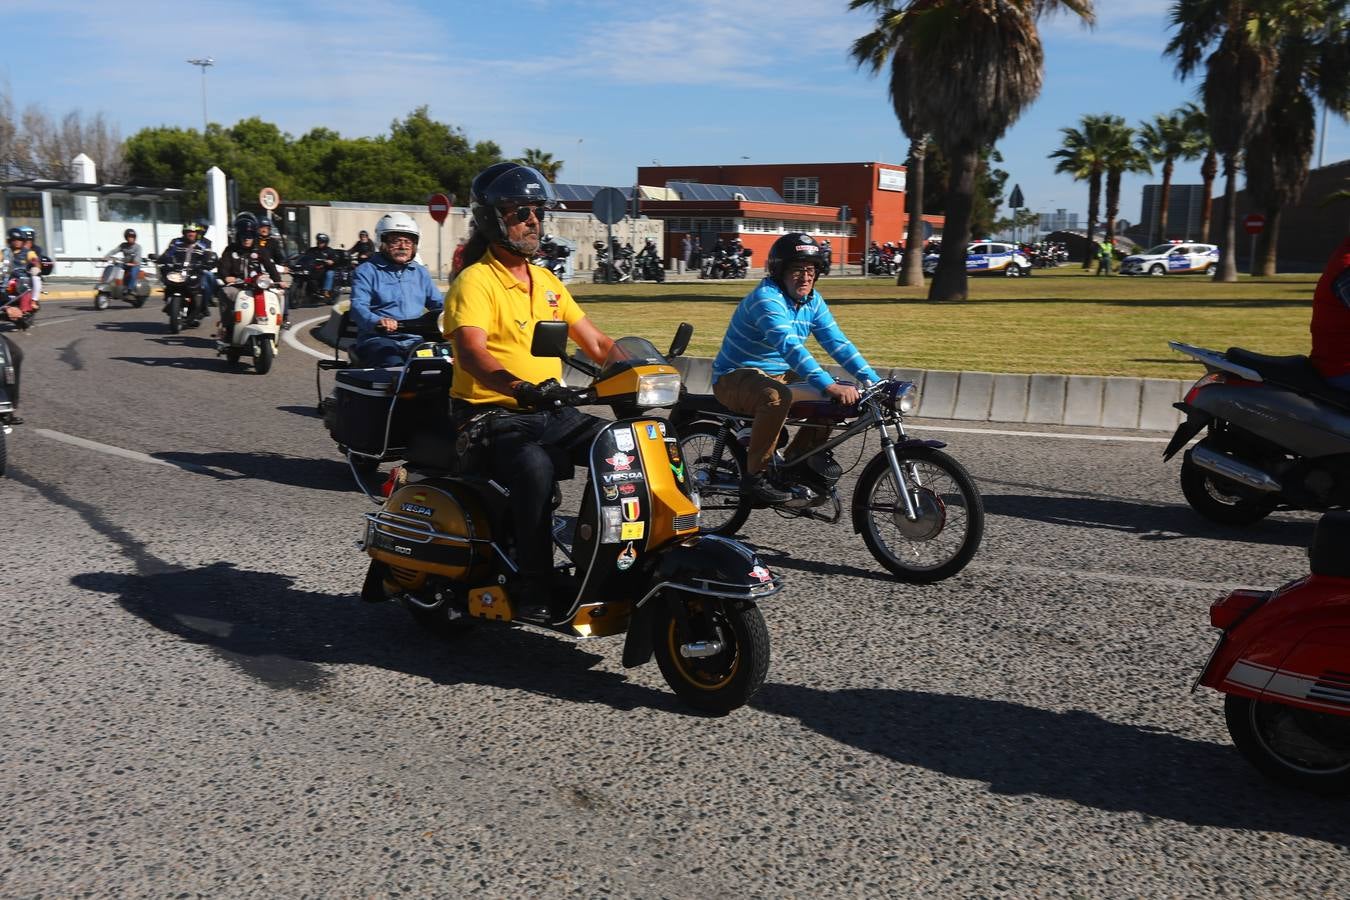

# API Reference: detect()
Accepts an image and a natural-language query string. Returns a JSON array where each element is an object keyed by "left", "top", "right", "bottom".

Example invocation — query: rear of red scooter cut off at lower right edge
[{"left": 1192, "top": 511, "right": 1350, "bottom": 793}]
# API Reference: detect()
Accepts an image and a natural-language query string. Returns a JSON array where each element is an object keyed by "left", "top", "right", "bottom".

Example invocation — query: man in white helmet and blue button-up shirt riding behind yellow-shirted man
[{"left": 350, "top": 212, "right": 446, "bottom": 368}]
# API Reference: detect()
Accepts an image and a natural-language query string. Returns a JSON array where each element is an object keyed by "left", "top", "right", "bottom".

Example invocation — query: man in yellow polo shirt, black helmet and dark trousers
[{"left": 444, "top": 162, "right": 614, "bottom": 621}]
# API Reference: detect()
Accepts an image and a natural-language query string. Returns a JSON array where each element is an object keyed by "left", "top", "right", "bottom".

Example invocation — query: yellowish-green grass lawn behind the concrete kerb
[{"left": 571, "top": 266, "right": 1318, "bottom": 379}]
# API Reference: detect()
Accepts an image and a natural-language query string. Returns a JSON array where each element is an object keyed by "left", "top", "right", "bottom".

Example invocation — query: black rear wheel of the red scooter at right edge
[{"left": 1223, "top": 694, "right": 1350, "bottom": 793}]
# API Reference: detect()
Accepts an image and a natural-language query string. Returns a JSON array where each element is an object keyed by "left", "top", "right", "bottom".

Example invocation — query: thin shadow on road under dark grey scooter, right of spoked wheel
[{"left": 984, "top": 494, "right": 1314, "bottom": 546}]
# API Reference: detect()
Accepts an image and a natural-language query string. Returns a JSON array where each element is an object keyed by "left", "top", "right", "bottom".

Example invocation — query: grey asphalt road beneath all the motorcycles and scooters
[{"left": 0, "top": 295, "right": 1350, "bottom": 899}]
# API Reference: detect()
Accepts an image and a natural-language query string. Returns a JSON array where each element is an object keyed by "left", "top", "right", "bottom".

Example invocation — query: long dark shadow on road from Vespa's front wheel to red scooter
[{"left": 751, "top": 684, "right": 1350, "bottom": 845}]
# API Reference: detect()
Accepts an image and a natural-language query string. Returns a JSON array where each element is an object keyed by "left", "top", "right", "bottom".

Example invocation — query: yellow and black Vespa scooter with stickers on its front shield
[{"left": 360, "top": 321, "right": 780, "bottom": 714}]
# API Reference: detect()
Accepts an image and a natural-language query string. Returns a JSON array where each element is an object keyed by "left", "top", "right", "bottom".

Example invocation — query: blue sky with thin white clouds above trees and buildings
[{"left": 13, "top": 0, "right": 1350, "bottom": 221}]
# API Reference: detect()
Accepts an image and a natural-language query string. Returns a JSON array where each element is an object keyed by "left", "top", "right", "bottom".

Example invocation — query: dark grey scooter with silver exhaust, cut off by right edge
[{"left": 1162, "top": 341, "right": 1350, "bottom": 525}]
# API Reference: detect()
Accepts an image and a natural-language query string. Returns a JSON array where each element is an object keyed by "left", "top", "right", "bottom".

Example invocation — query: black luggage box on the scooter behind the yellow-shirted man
[{"left": 331, "top": 360, "right": 452, "bottom": 456}]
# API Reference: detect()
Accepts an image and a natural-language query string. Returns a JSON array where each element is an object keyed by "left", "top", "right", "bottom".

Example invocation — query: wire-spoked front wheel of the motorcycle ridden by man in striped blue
[{"left": 853, "top": 447, "right": 984, "bottom": 584}]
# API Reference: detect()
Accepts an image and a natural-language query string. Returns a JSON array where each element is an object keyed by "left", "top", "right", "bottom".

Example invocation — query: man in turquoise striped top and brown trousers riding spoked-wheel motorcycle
[{"left": 713, "top": 232, "right": 880, "bottom": 503}]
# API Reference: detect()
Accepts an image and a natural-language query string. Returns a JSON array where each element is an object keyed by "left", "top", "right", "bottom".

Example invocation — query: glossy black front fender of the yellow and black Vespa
[{"left": 624, "top": 534, "right": 783, "bottom": 669}]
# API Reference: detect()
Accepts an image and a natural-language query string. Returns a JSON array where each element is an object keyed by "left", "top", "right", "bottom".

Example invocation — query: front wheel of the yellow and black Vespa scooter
[{"left": 652, "top": 592, "right": 770, "bottom": 715}]
